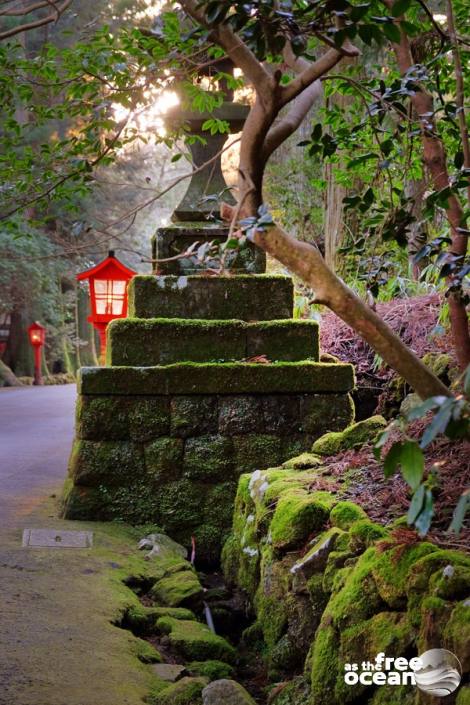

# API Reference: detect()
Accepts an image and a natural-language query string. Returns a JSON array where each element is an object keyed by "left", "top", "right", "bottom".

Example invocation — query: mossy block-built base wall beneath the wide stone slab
[{"left": 65, "top": 394, "right": 354, "bottom": 559}]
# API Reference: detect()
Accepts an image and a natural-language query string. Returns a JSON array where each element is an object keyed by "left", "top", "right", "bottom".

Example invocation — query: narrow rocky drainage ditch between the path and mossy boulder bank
[{"left": 115, "top": 536, "right": 268, "bottom": 705}]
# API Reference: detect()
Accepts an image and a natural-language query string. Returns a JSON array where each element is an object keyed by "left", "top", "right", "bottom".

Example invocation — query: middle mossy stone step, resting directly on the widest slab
[{"left": 107, "top": 318, "right": 319, "bottom": 366}]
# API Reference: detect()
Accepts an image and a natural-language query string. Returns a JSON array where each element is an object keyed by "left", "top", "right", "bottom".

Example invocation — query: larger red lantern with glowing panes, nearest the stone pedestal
[{"left": 77, "top": 250, "right": 137, "bottom": 363}]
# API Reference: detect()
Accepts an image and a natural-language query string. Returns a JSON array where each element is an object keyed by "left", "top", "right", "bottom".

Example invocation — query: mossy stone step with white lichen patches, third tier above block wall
[{"left": 128, "top": 274, "right": 294, "bottom": 321}]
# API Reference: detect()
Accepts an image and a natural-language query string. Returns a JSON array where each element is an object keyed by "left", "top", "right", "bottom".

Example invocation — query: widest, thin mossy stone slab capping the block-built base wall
[{"left": 78, "top": 362, "right": 354, "bottom": 396}]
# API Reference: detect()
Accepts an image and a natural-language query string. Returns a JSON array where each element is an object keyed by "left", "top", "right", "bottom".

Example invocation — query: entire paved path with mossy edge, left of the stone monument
[{"left": 0, "top": 385, "right": 160, "bottom": 705}]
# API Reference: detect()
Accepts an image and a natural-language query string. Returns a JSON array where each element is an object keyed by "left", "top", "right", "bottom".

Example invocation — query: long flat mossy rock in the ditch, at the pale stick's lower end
[{"left": 157, "top": 617, "right": 237, "bottom": 664}]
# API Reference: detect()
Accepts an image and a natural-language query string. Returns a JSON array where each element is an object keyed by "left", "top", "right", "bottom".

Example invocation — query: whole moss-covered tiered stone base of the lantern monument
[{"left": 64, "top": 80, "right": 354, "bottom": 560}]
